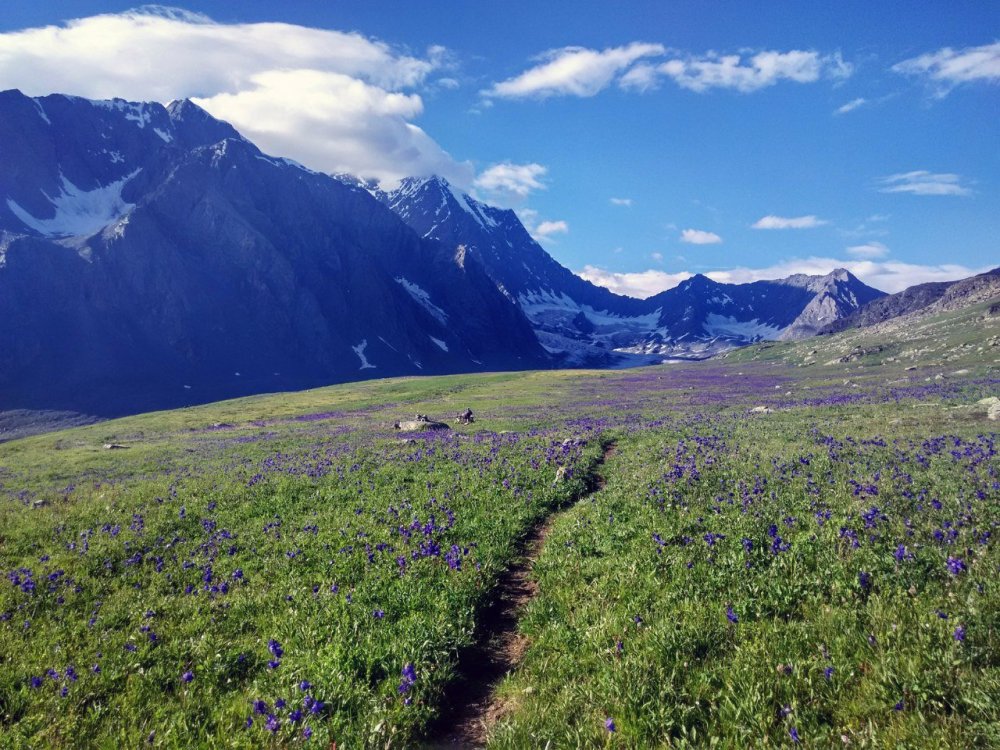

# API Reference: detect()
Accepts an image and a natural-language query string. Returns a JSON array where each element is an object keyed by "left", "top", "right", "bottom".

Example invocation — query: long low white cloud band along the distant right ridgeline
[{"left": 577, "top": 257, "right": 989, "bottom": 297}]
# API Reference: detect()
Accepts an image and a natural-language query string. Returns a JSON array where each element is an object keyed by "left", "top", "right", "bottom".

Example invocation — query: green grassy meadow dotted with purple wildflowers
[{"left": 0, "top": 302, "right": 1000, "bottom": 748}]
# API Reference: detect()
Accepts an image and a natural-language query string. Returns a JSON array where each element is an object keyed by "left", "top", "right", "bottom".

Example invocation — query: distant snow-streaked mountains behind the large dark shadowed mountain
[{"left": 378, "top": 177, "right": 883, "bottom": 366}]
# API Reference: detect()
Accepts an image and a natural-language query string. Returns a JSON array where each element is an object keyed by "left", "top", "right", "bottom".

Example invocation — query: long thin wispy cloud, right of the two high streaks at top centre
[{"left": 619, "top": 50, "right": 853, "bottom": 93}]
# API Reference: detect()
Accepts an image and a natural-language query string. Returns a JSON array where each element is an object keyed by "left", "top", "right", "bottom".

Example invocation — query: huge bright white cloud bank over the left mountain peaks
[{"left": 0, "top": 6, "right": 472, "bottom": 185}]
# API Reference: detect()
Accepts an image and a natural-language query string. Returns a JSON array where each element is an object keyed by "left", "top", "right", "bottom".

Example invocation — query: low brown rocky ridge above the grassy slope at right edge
[{"left": 819, "top": 268, "right": 1000, "bottom": 334}]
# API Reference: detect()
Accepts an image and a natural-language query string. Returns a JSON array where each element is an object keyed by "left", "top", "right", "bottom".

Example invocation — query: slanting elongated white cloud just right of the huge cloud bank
[{"left": 483, "top": 42, "right": 666, "bottom": 99}]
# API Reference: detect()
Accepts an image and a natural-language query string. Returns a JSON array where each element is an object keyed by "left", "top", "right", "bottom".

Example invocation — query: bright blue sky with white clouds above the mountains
[{"left": 0, "top": 0, "right": 1000, "bottom": 295}]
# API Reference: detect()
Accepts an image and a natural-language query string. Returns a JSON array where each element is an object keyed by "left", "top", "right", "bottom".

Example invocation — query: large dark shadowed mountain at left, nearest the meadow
[{"left": 0, "top": 91, "right": 550, "bottom": 414}]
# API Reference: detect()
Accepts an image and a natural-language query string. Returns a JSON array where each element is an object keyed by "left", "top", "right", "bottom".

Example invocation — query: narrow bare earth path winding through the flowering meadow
[{"left": 426, "top": 443, "right": 616, "bottom": 749}]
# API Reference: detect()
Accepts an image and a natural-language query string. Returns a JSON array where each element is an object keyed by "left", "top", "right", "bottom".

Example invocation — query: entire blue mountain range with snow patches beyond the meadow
[{"left": 0, "top": 91, "right": 988, "bottom": 416}]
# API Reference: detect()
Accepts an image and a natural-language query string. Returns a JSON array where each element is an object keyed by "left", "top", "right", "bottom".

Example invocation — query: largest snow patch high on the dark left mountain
[{"left": 7, "top": 169, "right": 140, "bottom": 237}]
